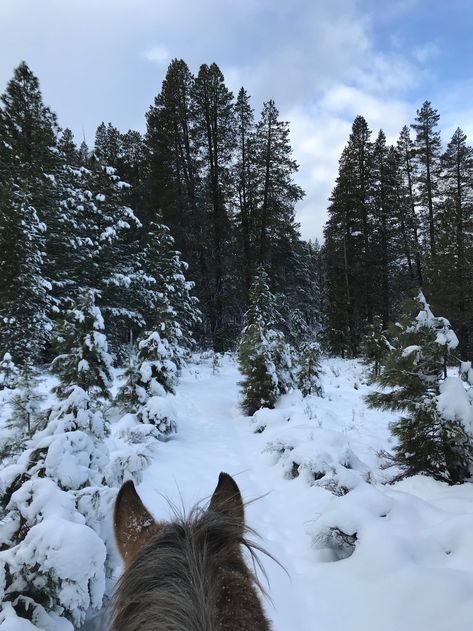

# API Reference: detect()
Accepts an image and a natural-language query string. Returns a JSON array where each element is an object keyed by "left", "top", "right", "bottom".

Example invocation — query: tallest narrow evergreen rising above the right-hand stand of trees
[{"left": 411, "top": 101, "right": 441, "bottom": 257}]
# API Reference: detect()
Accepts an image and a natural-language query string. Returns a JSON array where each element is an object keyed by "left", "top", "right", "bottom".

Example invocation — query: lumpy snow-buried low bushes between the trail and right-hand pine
[{"left": 251, "top": 362, "right": 387, "bottom": 495}]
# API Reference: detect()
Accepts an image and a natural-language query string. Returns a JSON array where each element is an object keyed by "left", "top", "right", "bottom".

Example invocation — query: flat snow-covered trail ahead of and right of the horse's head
[{"left": 139, "top": 364, "right": 327, "bottom": 631}]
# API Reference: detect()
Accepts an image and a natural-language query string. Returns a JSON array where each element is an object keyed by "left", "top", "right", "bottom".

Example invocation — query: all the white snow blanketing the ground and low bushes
[{"left": 0, "top": 354, "right": 473, "bottom": 631}]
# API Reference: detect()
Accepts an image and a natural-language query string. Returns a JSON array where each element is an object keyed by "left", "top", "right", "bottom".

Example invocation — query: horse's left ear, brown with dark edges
[{"left": 113, "top": 480, "right": 156, "bottom": 567}]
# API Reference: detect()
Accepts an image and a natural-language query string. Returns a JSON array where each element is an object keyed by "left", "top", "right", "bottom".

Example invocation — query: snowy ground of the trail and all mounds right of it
[{"left": 116, "top": 358, "right": 473, "bottom": 631}]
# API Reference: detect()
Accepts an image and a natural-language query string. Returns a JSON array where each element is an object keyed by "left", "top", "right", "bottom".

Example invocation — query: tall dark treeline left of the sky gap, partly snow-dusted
[{"left": 0, "top": 60, "right": 320, "bottom": 363}]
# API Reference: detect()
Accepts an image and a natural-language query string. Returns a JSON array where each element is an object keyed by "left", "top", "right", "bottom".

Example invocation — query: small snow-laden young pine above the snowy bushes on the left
[{"left": 51, "top": 291, "right": 112, "bottom": 399}]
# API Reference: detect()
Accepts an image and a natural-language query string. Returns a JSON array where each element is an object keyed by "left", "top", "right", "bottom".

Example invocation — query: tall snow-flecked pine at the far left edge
[{"left": 0, "top": 62, "right": 59, "bottom": 363}]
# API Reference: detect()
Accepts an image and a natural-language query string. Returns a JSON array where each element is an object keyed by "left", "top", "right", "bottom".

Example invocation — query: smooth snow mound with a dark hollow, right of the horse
[{"left": 309, "top": 476, "right": 473, "bottom": 631}]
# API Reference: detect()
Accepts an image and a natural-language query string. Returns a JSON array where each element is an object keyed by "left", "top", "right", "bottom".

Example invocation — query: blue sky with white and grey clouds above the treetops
[{"left": 0, "top": 0, "right": 473, "bottom": 239}]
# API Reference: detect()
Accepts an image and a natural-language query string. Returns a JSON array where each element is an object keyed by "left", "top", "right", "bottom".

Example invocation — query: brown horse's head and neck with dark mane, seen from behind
[{"left": 112, "top": 473, "right": 270, "bottom": 631}]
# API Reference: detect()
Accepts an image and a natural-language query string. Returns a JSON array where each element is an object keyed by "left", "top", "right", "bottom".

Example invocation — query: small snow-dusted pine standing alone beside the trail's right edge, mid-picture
[{"left": 239, "top": 267, "right": 283, "bottom": 415}]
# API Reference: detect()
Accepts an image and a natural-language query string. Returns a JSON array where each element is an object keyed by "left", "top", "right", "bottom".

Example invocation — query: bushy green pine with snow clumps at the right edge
[{"left": 367, "top": 293, "right": 473, "bottom": 484}]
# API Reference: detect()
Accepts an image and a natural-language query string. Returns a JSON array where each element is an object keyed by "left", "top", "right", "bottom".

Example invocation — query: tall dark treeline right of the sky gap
[{"left": 325, "top": 101, "right": 473, "bottom": 358}]
